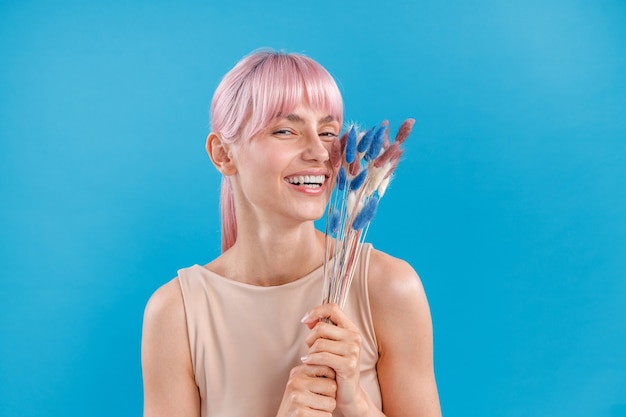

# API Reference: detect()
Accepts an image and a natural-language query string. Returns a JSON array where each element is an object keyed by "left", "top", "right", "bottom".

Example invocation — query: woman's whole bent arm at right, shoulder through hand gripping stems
[{"left": 303, "top": 251, "right": 441, "bottom": 417}]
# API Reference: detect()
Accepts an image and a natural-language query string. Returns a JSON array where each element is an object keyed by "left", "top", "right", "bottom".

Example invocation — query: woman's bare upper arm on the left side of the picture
[{"left": 141, "top": 279, "right": 200, "bottom": 417}]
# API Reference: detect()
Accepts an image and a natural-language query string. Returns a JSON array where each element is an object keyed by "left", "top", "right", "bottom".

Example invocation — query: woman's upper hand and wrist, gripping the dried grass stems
[{"left": 302, "top": 304, "right": 365, "bottom": 416}]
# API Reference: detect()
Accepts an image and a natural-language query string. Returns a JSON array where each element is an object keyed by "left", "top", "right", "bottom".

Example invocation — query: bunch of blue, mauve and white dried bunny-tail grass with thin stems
[{"left": 322, "top": 119, "right": 415, "bottom": 308}]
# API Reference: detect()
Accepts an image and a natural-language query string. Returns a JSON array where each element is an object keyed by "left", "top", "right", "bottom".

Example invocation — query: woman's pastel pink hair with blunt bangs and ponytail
[{"left": 211, "top": 50, "right": 343, "bottom": 252}]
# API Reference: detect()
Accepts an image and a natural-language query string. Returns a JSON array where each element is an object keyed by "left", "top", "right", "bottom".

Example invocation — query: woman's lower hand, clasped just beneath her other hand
[{"left": 277, "top": 365, "right": 337, "bottom": 417}]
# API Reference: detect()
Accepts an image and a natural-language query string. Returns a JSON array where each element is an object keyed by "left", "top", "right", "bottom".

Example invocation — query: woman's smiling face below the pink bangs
[{"left": 231, "top": 104, "right": 341, "bottom": 229}]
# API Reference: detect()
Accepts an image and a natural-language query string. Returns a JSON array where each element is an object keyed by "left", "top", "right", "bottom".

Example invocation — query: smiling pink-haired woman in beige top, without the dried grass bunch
[{"left": 142, "top": 51, "right": 441, "bottom": 417}]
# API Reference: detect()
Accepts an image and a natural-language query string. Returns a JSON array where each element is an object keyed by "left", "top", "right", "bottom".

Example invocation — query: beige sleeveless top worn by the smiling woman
[{"left": 178, "top": 245, "right": 382, "bottom": 417}]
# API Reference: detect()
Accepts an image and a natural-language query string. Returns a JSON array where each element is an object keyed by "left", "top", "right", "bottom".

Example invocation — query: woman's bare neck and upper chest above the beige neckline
[{"left": 207, "top": 222, "right": 324, "bottom": 286}]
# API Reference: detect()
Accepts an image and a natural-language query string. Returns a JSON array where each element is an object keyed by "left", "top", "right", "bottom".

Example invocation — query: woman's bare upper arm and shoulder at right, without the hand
[{"left": 369, "top": 251, "right": 441, "bottom": 417}]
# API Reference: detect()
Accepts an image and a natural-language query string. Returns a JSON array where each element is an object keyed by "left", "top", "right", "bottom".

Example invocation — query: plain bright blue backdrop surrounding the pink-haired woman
[{"left": 0, "top": 0, "right": 626, "bottom": 417}]
